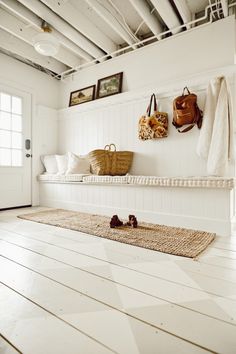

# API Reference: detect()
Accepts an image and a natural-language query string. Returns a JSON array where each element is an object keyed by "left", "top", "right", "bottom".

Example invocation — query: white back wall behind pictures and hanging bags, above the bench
[{"left": 58, "top": 17, "right": 235, "bottom": 176}]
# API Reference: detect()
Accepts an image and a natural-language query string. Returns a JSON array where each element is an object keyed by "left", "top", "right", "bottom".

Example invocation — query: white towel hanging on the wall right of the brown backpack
[{"left": 197, "top": 77, "right": 233, "bottom": 176}]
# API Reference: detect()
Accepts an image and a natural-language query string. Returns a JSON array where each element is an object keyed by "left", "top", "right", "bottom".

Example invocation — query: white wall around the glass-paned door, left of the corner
[{"left": 0, "top": 54, "right": 59, "bottom": 205}]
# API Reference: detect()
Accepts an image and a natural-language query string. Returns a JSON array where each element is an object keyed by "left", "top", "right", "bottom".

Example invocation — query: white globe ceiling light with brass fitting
[{"left": 33, "top": 21, "right": 60, "bottom": 56}]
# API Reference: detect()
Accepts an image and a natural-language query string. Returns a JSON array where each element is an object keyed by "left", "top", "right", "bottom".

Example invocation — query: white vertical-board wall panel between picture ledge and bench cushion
[{"left": 58, "top": 90, "right": 232, "bottom": 176}]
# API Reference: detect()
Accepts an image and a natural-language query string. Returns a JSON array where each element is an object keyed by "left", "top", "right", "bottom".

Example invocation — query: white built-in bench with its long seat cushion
[{"left": 38, "top": 174, "right": 235, "bottom": 236}]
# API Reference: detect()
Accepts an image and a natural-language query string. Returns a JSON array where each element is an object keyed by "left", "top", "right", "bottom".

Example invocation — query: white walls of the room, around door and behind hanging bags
[{"left": 0, "top": 17, "right": 235, "bottom": 210}]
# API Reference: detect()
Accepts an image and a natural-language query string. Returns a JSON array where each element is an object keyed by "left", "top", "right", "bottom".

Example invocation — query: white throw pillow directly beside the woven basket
[{"left": 66, "top": 152, "right": 90, "bottom": 175}]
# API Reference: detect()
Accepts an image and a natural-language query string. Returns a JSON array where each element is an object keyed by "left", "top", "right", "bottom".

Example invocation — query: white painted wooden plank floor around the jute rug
[{"left": 0, "top": 208, "right": 236, "bottom": 354}]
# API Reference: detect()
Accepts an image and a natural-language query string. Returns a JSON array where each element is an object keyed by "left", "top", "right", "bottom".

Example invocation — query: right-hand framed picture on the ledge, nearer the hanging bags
[{"left": 96, "top": 73, "right": 123, "bottom": 98}]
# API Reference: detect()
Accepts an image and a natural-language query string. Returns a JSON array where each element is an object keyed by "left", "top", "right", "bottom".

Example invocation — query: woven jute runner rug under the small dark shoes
[{"left": 18, "top": 209, "right": 215, "bottom": 258}]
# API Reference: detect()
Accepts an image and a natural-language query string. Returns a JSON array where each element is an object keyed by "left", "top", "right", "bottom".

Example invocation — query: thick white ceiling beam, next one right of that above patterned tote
[{"left": 151, "top": 0, "right": 181, "bottom": 33}]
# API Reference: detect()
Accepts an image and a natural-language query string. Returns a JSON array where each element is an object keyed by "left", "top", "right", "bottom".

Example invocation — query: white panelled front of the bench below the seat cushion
[{"left": 40, "top": 182, "right": 234, "bottom": 236}]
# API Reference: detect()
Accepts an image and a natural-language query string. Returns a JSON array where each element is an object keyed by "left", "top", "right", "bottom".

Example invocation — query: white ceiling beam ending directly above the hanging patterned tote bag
[{"left": 129, "top": 0, "right": 163, "bottom": 36}]
